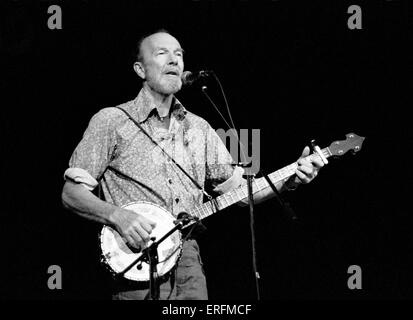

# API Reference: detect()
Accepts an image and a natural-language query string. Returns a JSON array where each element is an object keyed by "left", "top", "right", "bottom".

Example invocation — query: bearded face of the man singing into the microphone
[{"left": 140, "top": 33, "right": 184, "bottom": 95}]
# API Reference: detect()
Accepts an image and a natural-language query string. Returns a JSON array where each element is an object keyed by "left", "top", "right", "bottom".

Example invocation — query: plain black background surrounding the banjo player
[{"left": 0, "top": 0, "right": 413, "bottom": 300}]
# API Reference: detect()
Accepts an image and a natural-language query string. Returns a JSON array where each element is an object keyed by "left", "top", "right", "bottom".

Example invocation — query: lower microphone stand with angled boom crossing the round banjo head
[{"left": 117, "top": 212, "right": 193, "bottom": 300}]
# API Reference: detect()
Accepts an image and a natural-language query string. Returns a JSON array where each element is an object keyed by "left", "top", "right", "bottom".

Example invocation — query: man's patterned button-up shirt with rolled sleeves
[{"left": 65, "top": 88, "right": 243, "bottom": 215}]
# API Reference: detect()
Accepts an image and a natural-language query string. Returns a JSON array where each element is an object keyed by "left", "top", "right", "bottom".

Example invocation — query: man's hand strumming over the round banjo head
[{"left": 111, "top": 208, "right": 156, "bottom": 250}]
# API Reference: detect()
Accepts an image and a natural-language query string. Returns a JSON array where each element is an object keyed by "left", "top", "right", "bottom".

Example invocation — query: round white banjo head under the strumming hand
[{"left": 99, "top": 201, "right": 182, "bottom": 281}]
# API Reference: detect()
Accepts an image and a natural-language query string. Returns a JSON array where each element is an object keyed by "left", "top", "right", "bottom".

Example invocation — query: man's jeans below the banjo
[{"left": 112, "top": 239, "right": 208, "bottom": 300}]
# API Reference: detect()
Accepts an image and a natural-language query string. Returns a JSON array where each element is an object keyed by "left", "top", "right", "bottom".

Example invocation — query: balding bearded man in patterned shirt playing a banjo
[{"left": 62, "top": 30, "right": 323, "bottom": 300}]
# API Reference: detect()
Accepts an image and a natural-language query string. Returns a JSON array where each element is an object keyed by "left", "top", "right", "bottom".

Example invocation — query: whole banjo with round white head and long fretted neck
[{"left": 99, "top": 133, "right": 365, "bottom": 282}]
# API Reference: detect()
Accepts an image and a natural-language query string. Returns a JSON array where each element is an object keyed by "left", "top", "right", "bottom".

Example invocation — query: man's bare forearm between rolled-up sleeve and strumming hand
[{"left": 62, "top": 181, "right": 118, "bottom": 225}]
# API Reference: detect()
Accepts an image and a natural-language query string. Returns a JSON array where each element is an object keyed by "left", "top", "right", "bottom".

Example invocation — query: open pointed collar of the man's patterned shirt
[{"left": 134, "top": 88, "right": 187, "bottom": 123}]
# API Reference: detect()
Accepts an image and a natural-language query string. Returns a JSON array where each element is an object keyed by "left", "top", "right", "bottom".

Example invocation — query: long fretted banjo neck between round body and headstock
[{"left": 185, "top": 147, "right": 332, "bottom": 227}]
